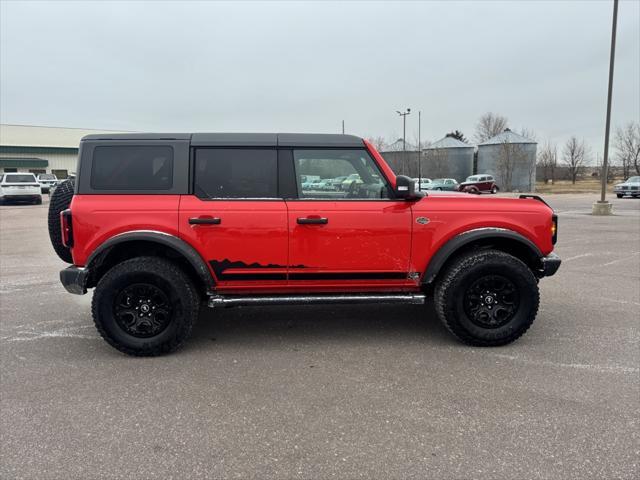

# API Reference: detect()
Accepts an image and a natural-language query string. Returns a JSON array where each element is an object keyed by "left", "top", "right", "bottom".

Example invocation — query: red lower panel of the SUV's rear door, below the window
[{"left": 179, "top": 195, "right": 288, "bottom": 291}]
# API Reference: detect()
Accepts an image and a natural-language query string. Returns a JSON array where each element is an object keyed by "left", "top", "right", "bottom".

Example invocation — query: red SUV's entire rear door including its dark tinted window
[{"left": 180, "top": 148, "right": 288, "bottom": 292}]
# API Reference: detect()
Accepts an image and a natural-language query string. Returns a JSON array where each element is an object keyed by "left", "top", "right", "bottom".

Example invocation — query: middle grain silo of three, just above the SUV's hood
[{"left": 422, "top": 137, "right": 474, "bottom": 182}]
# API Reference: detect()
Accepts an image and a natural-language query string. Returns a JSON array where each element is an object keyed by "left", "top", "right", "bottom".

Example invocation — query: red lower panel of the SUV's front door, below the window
[{"left": 287, "top": 200, "right": 415, "bottom": 289}]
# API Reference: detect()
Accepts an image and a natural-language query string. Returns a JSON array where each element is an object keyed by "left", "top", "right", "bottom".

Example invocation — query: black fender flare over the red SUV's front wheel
[{"left": 422, "top": 227, "right": 543, "bottom": 285}]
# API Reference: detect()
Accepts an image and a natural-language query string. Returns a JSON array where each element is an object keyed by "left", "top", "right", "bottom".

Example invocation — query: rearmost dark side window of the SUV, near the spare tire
[{"left": 91, "top": 145, "right": 173, "bottom": 190}]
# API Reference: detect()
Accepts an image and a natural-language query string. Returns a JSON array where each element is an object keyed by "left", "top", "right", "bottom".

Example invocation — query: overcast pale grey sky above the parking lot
[{"left": 0, "top": 0, "right": 640, "bottom": 152}]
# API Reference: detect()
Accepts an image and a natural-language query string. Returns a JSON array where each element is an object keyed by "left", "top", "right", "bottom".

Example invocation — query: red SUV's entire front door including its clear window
[{"left": 287, "top": 148, "right": 416, "bottom": 291}]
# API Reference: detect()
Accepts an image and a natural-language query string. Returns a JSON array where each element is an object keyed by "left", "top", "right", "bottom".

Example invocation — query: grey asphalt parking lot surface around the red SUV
[{"left": 0, "top": 195, "right": 640, "bottom": 479}]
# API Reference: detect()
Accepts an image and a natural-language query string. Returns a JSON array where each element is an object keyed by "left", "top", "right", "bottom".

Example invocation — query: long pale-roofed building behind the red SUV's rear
[{"left": 0, "top": 124, "right": 125, "bottom": 178}]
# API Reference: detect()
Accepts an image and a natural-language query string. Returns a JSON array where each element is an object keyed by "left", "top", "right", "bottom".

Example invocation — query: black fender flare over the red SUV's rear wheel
[{"left": 86, "top": 230, "right": 215, "bottom": 290}]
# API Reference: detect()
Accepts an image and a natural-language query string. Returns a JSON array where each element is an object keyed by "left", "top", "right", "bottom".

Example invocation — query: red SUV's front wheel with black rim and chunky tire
[{"left": 435, "top": 250, "right": 540, "bottom": 346}]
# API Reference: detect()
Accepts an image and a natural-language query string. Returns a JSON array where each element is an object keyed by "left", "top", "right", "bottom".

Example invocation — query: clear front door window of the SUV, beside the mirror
[{"left": 293, "top": 149, "right": 390, "bottom": 200}]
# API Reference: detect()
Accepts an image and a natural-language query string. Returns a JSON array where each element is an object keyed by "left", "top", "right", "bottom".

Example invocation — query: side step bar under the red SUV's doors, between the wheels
[{"left": 208, "top": 293, "right": 426, "bottom": 308}]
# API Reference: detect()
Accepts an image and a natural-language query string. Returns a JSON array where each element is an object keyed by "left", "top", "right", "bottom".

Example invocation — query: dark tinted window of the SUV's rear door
[{"left": 194, "top": 148, "right": 278, "bottom": 198}]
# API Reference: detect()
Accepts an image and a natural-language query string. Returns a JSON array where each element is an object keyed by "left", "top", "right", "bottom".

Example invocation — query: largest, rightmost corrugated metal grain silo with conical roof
[{"left": 477, "top": 128, "right": 538, "bottom": 192}]
